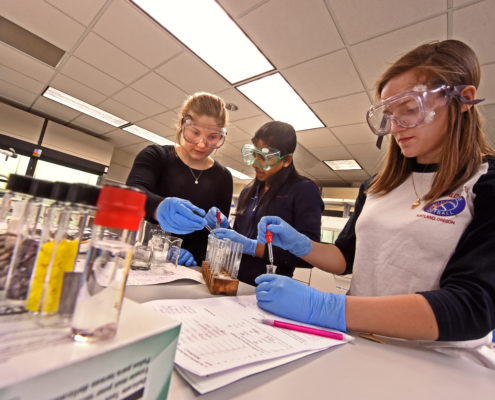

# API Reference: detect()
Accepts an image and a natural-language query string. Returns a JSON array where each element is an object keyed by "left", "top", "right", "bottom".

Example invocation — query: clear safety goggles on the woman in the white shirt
[{"left": 366, "top": 85, "right": 483, "bottom": 148}]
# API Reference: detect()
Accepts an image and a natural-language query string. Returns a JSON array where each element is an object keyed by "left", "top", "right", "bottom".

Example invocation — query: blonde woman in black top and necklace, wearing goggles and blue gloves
[{"left": 127, "top": 92, "right": 233, "bottom": 266}]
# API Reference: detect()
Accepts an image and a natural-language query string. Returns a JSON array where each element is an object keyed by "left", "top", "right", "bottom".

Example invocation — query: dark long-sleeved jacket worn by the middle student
[{"left": 234, "top": 179, "right": 324, "bottom": 285}]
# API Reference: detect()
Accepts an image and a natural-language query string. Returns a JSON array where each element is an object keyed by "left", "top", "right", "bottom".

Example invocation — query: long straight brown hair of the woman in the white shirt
[{"left": 367, "top": 40, "right": 494, "bottom": 205}]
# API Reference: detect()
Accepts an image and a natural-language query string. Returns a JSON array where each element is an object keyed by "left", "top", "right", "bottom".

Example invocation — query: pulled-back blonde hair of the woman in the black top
[{"left": 176, "top": 92, "right": 227, "bottom": 143}]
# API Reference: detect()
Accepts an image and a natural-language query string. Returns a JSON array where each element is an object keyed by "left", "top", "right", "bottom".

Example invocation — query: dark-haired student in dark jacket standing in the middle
[{"left": 215, "top": 121, "right": 323, "bottom": 284}]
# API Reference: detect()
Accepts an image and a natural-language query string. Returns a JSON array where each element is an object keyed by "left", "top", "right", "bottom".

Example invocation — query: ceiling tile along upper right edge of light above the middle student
[{"left": 282, "top": 49, "right": 364, "bottom": 103}]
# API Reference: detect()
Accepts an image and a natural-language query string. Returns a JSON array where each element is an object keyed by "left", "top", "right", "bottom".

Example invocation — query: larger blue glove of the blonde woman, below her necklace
[{"left": 156, "top": 197, "right": 206, "bottom": 234}]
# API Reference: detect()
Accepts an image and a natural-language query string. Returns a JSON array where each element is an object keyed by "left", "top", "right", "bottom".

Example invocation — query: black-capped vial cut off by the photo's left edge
[{"left": 0, "top": 174, "right": 34, "bottom": 299}]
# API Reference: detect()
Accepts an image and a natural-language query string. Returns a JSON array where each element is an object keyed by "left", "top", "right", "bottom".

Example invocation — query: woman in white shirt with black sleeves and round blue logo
[{"left": 256, "top": 40, "right": 495, "bottom": 368}]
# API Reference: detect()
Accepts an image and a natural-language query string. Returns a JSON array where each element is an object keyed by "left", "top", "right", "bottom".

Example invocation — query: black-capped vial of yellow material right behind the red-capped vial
[{"left": 34, "top": 183, "right": 101, "bottom": 326}]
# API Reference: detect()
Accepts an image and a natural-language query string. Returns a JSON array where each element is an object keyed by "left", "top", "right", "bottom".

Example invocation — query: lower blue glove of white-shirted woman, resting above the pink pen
[{"left": 254, "top": 274, "right": 346, "bottom": 332}]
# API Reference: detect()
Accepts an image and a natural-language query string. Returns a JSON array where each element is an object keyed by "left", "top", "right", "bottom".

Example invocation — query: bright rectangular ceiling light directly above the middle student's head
[{"left": 237, "top": 73, "right": 324, "bottom": 131}]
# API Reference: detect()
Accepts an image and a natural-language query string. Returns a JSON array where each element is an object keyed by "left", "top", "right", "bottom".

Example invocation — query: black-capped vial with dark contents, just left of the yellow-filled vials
[{"left": 5, "top": 179, "right": 53, "bottom": 306}]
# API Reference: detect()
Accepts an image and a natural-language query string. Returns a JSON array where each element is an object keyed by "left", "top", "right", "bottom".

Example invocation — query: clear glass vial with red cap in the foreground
[{"left": 71, "top": 185, "right": 146, "bottom": 342}]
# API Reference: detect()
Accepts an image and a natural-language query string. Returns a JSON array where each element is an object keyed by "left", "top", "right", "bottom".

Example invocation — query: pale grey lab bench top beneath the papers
[{"left": 126, "top": 281, "right": 495, "bottom": 400}]
